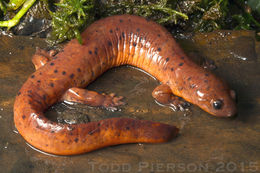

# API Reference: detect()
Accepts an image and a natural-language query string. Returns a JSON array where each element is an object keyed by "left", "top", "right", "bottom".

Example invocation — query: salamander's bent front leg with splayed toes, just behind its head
[{"left": 152, "top": 84, "right": 190, "bottom": 111}]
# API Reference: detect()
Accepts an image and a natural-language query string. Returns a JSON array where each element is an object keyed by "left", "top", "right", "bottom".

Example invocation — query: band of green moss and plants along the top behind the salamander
[{"left": 0, "top": 0, "right": 260, "bottom": 43}]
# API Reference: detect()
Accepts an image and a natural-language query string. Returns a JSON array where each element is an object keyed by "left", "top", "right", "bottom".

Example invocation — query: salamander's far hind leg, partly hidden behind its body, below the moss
[{"left": 32, "top": 48, "right": 56, "bottom": 70}]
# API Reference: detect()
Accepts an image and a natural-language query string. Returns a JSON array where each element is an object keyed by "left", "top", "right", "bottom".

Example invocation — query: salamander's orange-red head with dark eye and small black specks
[{"left": 172, "top": 69, "right": 236, "bottom": 117}]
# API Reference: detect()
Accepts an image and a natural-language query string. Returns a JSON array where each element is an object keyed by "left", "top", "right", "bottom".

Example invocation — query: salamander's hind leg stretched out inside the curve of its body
[{"left": 61, "top": 88, "right": 125, "bottom": 111}]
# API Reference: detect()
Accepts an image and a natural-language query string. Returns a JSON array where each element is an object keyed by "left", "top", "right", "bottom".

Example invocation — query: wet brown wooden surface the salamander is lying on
[{"left": 0, "top": 31, "right": 260, "bottom": 173}]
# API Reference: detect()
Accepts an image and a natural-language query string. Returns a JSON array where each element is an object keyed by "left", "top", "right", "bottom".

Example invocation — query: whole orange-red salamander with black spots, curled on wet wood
[{"left": 14, "top": 15, "right": 236, "bottom": 155}]
